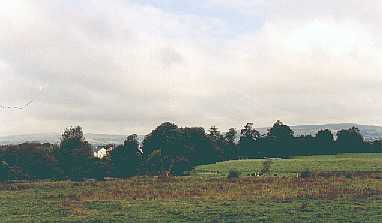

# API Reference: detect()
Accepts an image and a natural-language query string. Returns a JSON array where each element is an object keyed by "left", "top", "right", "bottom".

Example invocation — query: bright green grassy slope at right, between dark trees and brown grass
[{"left": 191, "top": 154, "right": 382, "bottom": 176}]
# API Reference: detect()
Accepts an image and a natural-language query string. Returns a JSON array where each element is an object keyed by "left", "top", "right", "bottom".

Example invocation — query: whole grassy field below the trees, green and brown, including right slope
[{"left": 0, "top": 155, "right": 382, "bottom": 222}]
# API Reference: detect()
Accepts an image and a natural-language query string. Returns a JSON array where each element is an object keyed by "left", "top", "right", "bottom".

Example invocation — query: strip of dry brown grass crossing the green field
[{"left": 0, "top": 175, "right": 382, "bottom": 217}]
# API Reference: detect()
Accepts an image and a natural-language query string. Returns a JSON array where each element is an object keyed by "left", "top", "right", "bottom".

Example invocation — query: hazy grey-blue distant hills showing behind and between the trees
[{"left": 0, "top": 123, "right": 382, "bottom": 146}]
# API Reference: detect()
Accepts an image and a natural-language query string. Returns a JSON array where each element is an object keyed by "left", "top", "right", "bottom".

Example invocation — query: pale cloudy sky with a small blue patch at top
[{"left": 0, "top": 0, "right": 382, "bottom": 135}]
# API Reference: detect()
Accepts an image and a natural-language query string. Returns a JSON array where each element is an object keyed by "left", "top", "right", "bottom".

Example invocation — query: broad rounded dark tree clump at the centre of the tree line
[{"left": 143, "top": 122, "right": 222, "bottom": 175}]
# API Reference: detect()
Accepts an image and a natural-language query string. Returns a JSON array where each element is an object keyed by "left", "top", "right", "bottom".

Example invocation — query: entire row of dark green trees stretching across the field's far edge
[{"left": 0, "top": 121, "right": 382, "bottom": 180}]
